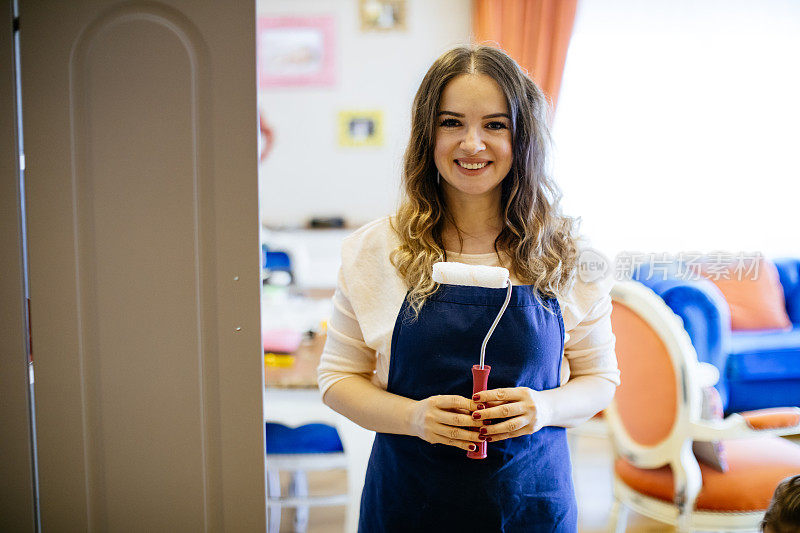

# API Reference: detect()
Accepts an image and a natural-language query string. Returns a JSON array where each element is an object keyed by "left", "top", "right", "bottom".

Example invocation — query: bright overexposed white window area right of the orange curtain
[{"left": 555, "top": 0, "right": 800, "bottom": 256}]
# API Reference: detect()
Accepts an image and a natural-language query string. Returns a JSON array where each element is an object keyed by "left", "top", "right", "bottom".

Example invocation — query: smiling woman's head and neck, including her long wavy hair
[{"left": 392, "top": 46, "right": 578, "bottom": 312}]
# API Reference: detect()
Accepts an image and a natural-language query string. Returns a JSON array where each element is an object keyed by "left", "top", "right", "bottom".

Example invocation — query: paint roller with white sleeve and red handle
[{"left": 433, "top": 262, "right": 511, "bottom": 459}]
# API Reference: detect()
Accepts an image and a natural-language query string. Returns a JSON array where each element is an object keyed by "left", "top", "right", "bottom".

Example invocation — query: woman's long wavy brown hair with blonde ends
[{"left": 390, "top": 45, "right": 578, "bottom": 317}]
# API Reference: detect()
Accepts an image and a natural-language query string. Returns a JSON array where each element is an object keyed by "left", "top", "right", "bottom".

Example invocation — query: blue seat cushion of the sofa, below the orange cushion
[{"left": 725, "top": 327, "right": 800, "bottom": 381}]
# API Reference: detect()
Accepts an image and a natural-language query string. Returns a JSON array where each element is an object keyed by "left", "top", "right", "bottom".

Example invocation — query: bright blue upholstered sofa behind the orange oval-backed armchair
[{"left": 633, "top": 259, "right": 800, "bottom": 416}]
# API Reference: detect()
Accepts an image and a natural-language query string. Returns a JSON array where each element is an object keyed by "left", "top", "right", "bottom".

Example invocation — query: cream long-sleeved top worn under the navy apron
[{"left": 317, "top": 217, "right": 620, "bottom": 395}]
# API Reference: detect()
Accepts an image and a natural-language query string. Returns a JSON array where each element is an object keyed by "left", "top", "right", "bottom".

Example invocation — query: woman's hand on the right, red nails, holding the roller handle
[{"left": 472, "top": 387, "right": 550, "bottom": 442}]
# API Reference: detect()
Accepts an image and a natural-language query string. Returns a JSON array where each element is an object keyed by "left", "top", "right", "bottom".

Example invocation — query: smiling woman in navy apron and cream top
[{"left": 319, "top": 46, "right": 619, "bottom": 532}]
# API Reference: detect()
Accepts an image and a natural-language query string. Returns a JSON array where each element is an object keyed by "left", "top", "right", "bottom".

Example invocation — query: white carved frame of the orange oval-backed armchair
[{"left": 605, "top": 281, "right": 800, "bottom": 532}]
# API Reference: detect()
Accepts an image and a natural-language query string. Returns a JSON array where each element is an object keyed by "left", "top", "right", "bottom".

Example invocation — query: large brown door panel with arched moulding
[{"left": 20, "top": 0, "right": 265, "bottom": 531}]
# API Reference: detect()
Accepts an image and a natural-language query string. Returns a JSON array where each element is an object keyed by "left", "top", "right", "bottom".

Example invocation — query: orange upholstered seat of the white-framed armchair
[{"left": 614, "top": 436, "right": 800, "bottom": 512}]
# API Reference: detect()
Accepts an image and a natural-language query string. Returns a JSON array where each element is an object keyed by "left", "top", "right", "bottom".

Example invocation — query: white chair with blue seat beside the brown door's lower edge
[{"left": 265, "top": 422, "right": 349, "bottom": 533}]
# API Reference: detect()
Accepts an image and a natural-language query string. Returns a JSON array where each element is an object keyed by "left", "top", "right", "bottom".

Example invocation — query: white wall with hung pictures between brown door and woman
[{"left": 257, "top": 0, "right": 471, "bottom": 225}]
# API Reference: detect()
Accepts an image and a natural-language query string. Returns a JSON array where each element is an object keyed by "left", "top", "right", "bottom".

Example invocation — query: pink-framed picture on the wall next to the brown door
[{"left": 256, "top": 15, "right": 336, "bottom": 89}]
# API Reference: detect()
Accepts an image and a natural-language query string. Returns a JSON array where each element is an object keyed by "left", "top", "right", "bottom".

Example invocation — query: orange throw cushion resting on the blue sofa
[{"left": 701, "top": 258, "right": 792, "bottom": 331}]
